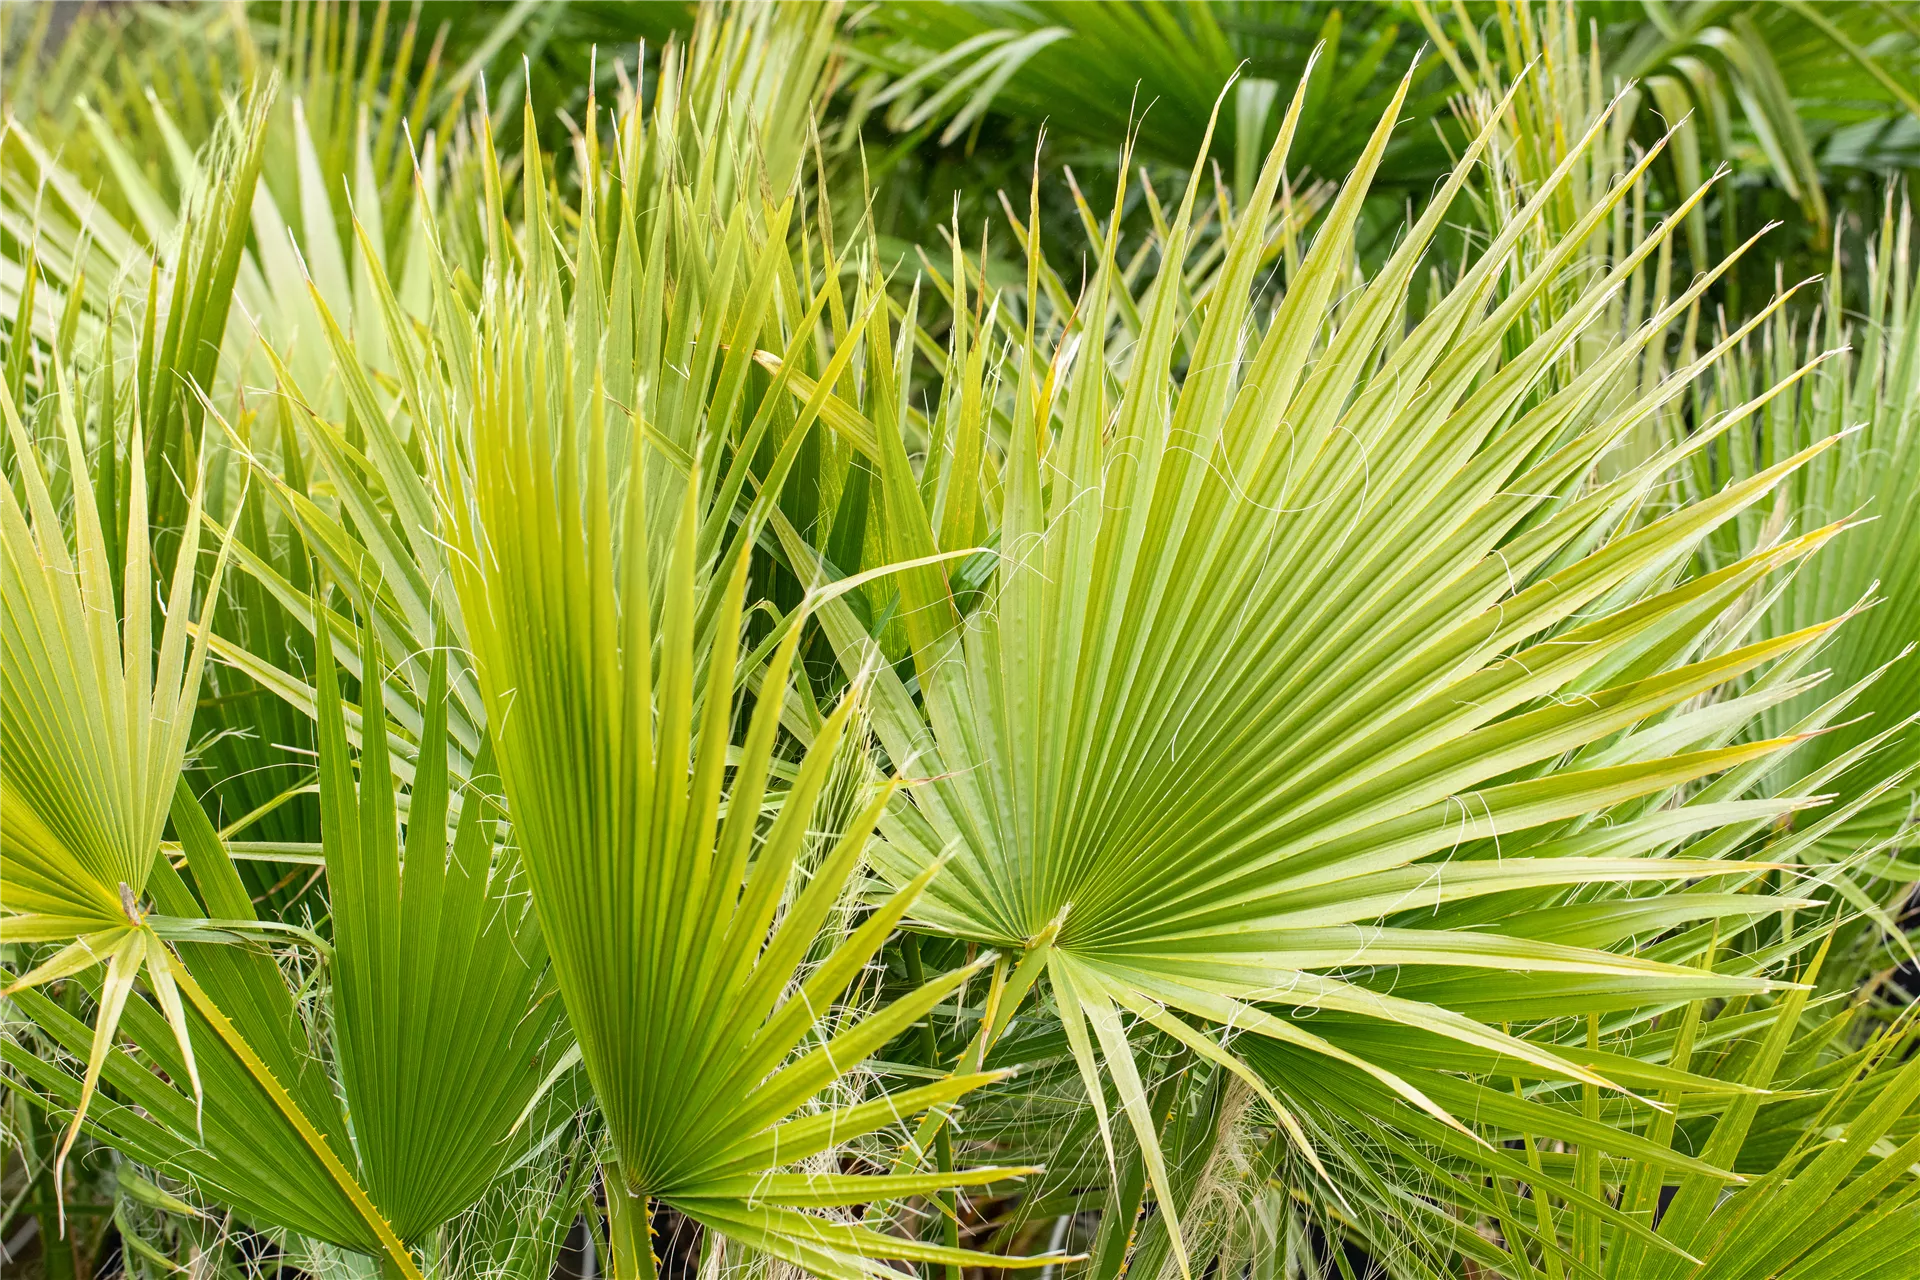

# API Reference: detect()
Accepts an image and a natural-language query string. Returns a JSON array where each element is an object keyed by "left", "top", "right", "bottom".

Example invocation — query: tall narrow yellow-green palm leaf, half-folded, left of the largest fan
[{"left": 444, "top": 272, "right": 1044, "bottom": 1276}]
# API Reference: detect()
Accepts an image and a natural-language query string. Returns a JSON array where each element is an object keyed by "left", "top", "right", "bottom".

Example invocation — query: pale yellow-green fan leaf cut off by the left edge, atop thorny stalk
[{"left": 0, "top": 355, "right": 227, "bottom": 1189}]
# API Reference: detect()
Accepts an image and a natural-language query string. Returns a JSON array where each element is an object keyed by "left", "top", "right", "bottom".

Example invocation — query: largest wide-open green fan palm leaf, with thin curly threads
[{"left": 787, "top": 62, "right": 1873, "bottom": 1265}]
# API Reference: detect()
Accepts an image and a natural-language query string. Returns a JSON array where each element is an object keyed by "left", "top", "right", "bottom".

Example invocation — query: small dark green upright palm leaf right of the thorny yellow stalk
[{"left": 319, "top": 614, "right": 559, "bottom": 1240}]
